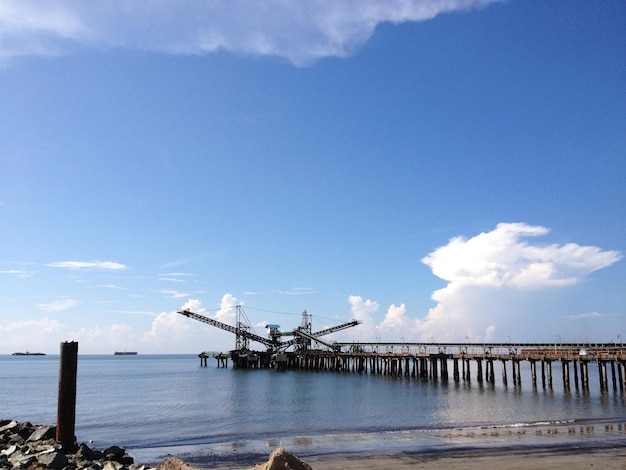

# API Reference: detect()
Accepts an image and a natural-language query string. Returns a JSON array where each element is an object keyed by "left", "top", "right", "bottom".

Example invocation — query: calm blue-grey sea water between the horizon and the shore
[{"left": 0, "top": 355, "right": 626, "bottom": 464}]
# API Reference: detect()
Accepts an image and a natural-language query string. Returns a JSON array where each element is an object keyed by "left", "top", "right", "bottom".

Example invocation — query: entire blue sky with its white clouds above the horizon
[{"left": 0, "top": 0, "right": 626, "bottom": 354}]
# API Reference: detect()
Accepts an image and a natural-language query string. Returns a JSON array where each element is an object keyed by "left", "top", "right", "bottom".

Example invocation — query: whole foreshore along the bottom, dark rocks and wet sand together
[{"left": 0, "top": 420, "right": 626, "bottom": 470}]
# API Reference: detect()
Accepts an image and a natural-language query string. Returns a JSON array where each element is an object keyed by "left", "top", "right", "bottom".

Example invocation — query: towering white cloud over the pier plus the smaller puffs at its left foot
[{"left": 348, "top": 223, "right": 622, "bottom": 342}]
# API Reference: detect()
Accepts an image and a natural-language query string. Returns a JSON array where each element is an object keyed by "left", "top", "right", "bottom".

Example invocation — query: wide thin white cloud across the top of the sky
[{"left": 0, "top": 0, "right": 502, "bottom": 65}]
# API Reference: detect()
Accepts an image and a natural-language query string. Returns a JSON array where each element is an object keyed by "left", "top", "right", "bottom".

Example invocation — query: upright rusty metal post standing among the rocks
[{"left": 56, "top": 341, "right": 78, "bottom": 450}]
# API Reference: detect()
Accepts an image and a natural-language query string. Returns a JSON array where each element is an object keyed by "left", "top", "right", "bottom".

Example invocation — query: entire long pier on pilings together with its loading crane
[{"left": 178, "top": 306, "right": 626, "bottom": 393}]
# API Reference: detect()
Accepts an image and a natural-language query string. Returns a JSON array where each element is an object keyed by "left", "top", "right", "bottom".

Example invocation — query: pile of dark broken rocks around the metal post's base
[{"left": 0, "top": 420, "right": 152, "bottom": 470}]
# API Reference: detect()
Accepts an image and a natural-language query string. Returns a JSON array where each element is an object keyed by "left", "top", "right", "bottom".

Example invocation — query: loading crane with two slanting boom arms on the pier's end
[{"left": 178, "top": 305, "right": 361, "bottom": 352}]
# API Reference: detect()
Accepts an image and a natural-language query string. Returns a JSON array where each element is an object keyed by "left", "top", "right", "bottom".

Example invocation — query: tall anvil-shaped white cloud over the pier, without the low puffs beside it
[{"left": 416, "top": 223, "right": 622, "bottom": 340}]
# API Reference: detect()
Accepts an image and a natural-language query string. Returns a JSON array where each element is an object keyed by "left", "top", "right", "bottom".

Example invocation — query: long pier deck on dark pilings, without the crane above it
[{"left": 217, "top": 343, "right": 626, "bottom": 392}]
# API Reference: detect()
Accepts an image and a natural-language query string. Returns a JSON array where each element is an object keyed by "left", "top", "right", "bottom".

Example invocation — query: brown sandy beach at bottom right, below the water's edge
[{"left": 178, "top": 423, "right": 626, "bottom": 470}]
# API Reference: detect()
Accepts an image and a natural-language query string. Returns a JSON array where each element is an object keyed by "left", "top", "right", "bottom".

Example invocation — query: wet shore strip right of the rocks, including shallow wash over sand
[{"left": 129, "top": 421, "right": 626, "bottom": 470}]
